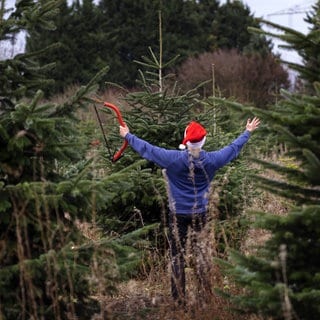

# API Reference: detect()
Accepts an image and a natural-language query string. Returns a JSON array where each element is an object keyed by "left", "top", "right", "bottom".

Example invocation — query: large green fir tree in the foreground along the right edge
[{"left": 214, "top": 3, "right": 320, "bottom": 320}]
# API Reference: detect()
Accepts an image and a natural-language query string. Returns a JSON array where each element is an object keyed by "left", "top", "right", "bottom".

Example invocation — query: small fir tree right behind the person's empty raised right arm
[{"left": 204, "top": 102, "right": 257, "bottom": 220}]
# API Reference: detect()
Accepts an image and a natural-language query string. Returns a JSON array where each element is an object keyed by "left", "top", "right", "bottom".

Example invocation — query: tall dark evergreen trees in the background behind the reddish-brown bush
[{"left": 27, "top": 0, "right": 271, "bottom": 94}]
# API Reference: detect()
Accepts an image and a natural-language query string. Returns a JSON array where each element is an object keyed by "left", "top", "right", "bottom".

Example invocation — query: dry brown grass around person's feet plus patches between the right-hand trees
[{"left": 92, "top": 151, "right": 290, "bottom": 320}]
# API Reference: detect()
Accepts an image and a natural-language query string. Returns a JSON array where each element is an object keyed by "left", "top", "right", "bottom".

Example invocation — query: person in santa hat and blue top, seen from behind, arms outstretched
[{"left": 120, "top": 117, "right": 260, "bottom": 303}]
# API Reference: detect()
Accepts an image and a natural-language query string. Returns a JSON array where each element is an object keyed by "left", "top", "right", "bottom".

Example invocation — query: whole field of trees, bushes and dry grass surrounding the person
[{"left": 0, "top": 0, "right": 320, "bottom": 320}]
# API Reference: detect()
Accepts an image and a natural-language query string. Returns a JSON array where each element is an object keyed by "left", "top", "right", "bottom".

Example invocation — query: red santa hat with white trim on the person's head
[{"left": 179, "top": 121, "right": 207, "bottom": 149}]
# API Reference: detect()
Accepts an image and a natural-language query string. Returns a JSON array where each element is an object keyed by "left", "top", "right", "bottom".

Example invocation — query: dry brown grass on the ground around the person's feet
[{"left": 90, "top": 215, "right": 268, "bottom": 320}]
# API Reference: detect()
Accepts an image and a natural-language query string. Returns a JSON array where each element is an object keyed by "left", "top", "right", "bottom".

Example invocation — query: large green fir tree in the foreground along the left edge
[{"left": 0, "top": 1, "right": 156, "bottom": 320}]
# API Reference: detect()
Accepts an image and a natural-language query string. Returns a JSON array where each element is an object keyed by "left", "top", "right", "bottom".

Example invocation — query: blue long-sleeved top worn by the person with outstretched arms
[{"left": 125, "top": 131, "right": 250, "bottom": 214}]
